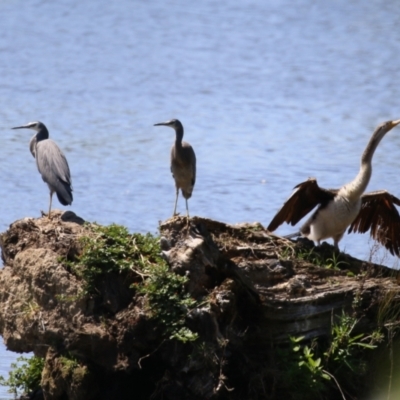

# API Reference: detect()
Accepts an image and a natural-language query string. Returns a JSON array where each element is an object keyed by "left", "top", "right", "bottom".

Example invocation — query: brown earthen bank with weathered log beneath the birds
[{"left": 0, "top": 212, "right": 400, "bottom": 400}]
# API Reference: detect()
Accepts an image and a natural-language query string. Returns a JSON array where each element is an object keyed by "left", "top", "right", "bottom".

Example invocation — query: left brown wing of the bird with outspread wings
[{"left": 267, "top": 178, "right": 338, "bottom": 232}]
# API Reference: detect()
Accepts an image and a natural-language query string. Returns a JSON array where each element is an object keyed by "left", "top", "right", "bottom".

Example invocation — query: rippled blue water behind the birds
[{"left": 0, "top": 0, "right": 400, "bottom": 398}]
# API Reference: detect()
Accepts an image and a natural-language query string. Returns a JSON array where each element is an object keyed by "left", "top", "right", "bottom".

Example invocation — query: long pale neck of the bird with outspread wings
[{"left": 344, "top": 127, "right": 388, "bottom": 200}]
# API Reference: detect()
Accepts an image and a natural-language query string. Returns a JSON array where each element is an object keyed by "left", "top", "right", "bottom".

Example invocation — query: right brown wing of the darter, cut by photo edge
[{"left": 348, "top": 190, "right": 400, "bottom": 257}]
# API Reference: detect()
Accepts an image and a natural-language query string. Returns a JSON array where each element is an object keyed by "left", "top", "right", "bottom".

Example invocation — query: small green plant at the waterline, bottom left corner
[{"left": 0, "top": 356, "right": 44, "bottom": 398}]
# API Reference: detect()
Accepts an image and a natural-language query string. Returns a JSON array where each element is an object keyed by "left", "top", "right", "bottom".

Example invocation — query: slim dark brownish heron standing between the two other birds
[{"left": 154, "top": 119, "right": 196, "bottom": 218}]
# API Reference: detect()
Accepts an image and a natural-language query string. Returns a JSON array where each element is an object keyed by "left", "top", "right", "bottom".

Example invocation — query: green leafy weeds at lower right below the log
[{"left": 282, "top": 313, "right": 384, "bottom": 400}]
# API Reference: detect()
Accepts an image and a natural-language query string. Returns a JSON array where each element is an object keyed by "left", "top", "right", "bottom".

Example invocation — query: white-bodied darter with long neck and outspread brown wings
[{"left": 268, "top": 120, "right": 400, "bottom": 256}]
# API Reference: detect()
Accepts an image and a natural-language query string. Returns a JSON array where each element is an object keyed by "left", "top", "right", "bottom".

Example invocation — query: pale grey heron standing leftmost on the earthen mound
[{"left": 12, "top": 121, "right": 73, "bottom": 218}]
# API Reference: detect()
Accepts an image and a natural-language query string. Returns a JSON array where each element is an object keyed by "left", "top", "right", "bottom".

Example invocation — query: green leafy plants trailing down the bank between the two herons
[{"left": 68, "top": 224, "right": 197, "bottom": 342}]
